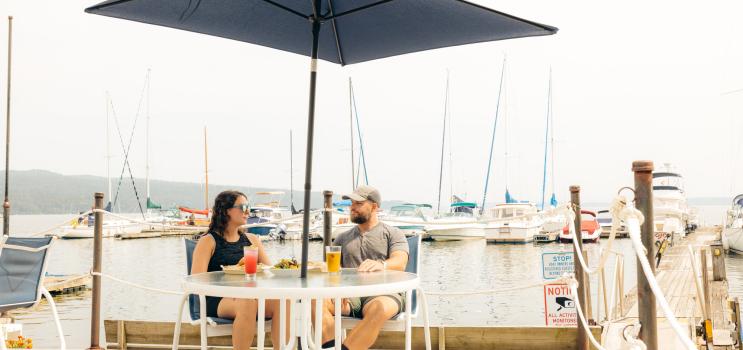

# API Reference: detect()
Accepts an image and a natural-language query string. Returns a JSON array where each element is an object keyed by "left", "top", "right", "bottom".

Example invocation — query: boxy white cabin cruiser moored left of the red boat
[{"left": 480, "top": 203, "right": 543, "bottom": 243}]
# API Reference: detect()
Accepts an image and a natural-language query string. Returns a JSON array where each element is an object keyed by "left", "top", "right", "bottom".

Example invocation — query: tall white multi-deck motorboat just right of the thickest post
[{"left": 653, "top": 163, "right": 689, "bottom": 237}]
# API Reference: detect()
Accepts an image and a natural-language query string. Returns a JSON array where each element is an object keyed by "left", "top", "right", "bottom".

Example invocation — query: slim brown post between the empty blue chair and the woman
[{"left": 88, "top": 192, "right": 103, "bottom": 350}]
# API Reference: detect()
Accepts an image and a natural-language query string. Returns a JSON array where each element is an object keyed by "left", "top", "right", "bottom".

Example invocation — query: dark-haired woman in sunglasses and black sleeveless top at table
[{"left": 191, "top": 191, "right": 289, "bottom": 350}]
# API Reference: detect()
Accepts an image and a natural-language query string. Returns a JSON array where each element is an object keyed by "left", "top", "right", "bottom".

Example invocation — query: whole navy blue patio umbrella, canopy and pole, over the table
[{"left": 85, "top": 0, "right": 557, "bottom": 278}]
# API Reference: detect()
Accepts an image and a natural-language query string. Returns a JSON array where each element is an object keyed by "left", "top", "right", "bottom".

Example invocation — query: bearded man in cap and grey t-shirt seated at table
[{"left": 313, "top": 186, "right": 408, "bottom": 350}]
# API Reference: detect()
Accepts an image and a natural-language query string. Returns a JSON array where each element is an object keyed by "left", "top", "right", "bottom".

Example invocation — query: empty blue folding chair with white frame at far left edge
[{"left": 0, "top": 235, "right": 67, "bottom": 350}]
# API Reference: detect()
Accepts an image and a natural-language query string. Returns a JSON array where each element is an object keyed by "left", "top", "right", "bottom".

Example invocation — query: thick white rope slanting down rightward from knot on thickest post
[{"left": 621, "top": 204, "right": 697, "bottom": 350}]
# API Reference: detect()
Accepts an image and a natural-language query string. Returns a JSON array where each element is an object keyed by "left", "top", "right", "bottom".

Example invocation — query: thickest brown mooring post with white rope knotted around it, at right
[{"left": 632, "top": 160, "right": 658, "bottom": 350}]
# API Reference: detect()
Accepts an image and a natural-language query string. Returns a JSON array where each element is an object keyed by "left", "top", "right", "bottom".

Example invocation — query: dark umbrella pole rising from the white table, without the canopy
[{"left": 300, "top": 14, "right": 320, "bottom": 278}]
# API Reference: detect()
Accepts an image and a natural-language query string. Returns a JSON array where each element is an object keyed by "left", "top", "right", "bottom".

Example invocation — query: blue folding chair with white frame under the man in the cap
[{"left": 341, "top": 234, "right": 431, "bottom": 350}]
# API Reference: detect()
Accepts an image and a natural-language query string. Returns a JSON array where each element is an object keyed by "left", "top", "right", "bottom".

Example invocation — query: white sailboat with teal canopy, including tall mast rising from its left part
[{"left": 425, "top": 72, "right": 485, "bottom": 241}]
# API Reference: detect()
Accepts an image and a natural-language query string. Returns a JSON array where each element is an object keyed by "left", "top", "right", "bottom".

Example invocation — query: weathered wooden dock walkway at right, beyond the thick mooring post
[{"left": 604, "top": 227, "right": 741, "bottom": 350}]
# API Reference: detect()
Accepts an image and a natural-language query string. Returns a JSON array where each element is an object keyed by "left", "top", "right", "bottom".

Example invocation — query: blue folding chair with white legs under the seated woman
[{"left": 173, "top": 239, "right": 271, "bottom": 350}]
